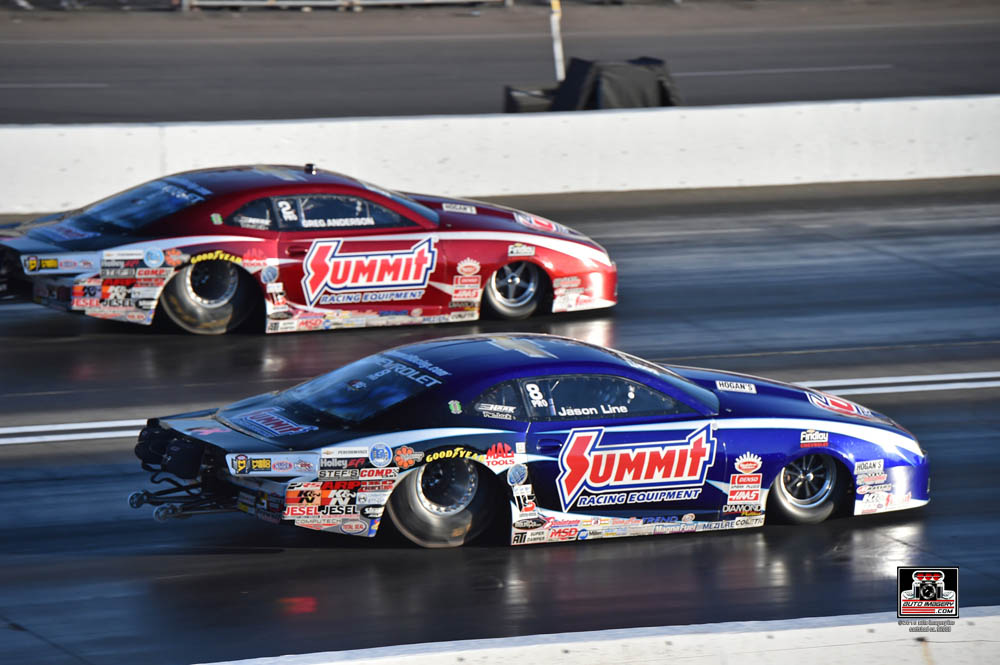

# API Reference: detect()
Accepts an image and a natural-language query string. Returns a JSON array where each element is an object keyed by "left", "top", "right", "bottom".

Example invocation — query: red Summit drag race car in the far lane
[{"left": 0, "top": 164, "right": 617, "bottom": 334}]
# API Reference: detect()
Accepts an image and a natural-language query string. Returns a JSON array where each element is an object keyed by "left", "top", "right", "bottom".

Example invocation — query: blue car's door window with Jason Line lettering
[{"left": 522, "top": 375, "right": 694, "bottom": 420}]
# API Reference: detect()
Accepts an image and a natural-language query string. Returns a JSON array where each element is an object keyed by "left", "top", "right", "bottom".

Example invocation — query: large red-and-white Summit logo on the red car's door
[{"left": 302, "top": 238, "right": 437, "bottom": 305}]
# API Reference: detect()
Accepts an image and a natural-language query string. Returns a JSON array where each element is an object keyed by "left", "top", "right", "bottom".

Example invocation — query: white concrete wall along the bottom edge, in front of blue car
[{"left": 201, "top": 599, "right": 1000, "bottom": 665}]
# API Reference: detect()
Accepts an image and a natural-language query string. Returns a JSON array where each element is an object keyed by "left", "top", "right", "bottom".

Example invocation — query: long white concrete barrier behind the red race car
[{"left": 0, "top": 96, "right": 1000, "bottom": 213}]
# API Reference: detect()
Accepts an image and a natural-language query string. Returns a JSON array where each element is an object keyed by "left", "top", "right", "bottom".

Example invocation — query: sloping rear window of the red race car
[{"left": 72, "top": 176, "right": 212, "bottom": 231}]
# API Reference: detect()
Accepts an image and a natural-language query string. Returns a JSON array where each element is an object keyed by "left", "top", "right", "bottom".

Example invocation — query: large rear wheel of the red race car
[{"left": 160, "top": 261, "right": 254, "bottom": 335}]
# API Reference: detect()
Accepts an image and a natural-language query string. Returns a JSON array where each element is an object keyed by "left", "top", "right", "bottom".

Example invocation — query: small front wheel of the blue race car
[{"left": 769, "top": 454, "right": 847, "bottom": 524}]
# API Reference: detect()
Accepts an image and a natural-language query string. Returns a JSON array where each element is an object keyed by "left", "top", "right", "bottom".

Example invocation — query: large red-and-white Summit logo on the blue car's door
[{"left": 556, "top": 425, "right": 717, "bottom": 510}]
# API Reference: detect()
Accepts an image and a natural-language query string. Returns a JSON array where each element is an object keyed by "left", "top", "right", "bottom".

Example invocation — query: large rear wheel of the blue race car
[{"left": 386, "top": 459, "right": 497, "bottom": 548}]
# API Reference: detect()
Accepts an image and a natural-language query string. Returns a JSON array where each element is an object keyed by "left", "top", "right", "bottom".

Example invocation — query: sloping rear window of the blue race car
[{"left": 282, "top": 351, "right": 447, "bottom": 423}]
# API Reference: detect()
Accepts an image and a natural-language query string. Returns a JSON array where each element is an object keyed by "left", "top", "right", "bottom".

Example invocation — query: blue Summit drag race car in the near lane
[{"left": 129, "top": 334, "right": 929, "bottom": 547}]
